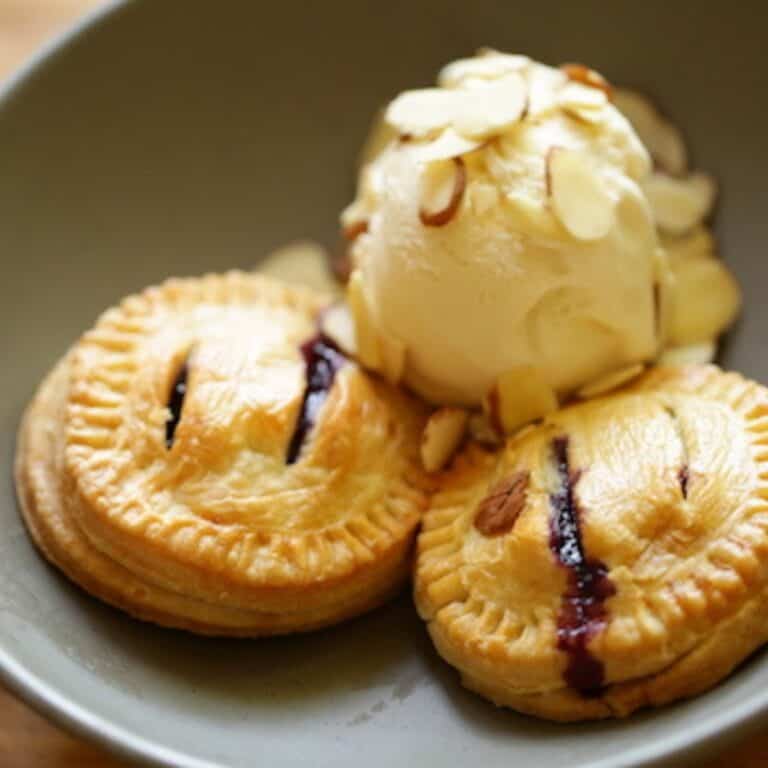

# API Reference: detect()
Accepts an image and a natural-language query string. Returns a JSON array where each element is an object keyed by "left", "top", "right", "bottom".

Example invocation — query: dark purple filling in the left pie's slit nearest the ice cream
[{"left": 285, "top": 333, "right": 347, "bottom": 464}]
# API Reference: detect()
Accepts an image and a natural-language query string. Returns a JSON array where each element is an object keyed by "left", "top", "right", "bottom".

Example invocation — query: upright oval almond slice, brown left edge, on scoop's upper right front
[{"left": 547, "top": 147, "right": 615, "bottom": 240}]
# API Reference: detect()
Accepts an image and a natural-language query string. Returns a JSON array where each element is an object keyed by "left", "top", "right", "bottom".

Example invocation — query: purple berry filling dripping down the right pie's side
[{"left": 549, "top": 437, "right": 616, "bottom": 696}]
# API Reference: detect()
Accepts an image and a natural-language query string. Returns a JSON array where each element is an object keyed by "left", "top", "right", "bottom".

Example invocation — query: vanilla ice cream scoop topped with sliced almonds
[{"left": 343, "top": 53, "right": 667, "bottom": 417}]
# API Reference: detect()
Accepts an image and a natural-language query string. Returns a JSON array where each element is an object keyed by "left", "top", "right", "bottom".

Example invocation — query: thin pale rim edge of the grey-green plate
[{"left": 0, "top": 0, "right": 768, "bottom": 768}]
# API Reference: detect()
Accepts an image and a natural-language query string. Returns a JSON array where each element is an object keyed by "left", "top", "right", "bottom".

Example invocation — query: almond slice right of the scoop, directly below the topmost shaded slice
[{"left": 641, "top": 173, "right": 717, "bottom": 235}]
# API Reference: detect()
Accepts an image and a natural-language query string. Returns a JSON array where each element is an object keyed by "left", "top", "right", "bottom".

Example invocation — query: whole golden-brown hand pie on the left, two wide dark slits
[{"left": 17, "top": 273, "right": 426, "bottom": 635}]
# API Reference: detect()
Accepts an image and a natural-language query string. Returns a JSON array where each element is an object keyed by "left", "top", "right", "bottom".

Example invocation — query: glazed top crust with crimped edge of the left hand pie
[{"left": 66, "top": 273, "right": 423, "bottom": 585}]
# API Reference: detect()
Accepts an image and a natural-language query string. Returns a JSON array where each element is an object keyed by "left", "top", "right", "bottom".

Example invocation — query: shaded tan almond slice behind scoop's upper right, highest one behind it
[{"left": 613, "top": 88, "right": 688, "bottom": 176}]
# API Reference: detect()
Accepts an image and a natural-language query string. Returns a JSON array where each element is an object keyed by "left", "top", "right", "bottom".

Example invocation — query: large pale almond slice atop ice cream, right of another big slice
[{"left": 452, "top": 72, "right": 528, "bottom": 139}]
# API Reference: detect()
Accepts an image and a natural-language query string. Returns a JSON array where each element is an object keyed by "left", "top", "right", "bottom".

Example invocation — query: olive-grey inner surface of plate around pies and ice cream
[{"left": 0, "top": 0, "right": 768, "bottom": 768}]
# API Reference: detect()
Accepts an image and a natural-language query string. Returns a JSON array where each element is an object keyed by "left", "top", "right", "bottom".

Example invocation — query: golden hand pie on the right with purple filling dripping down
[{"left": 415, "top": 366, "right": 768, "bottom": 720}]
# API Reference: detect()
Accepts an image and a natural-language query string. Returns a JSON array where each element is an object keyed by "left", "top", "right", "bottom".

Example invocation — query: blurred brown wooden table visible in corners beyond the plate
[{"left": 0, "top": 0, "right": 768, "bottom": 768}]
